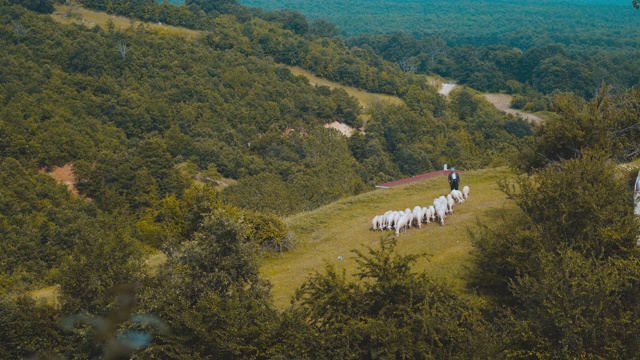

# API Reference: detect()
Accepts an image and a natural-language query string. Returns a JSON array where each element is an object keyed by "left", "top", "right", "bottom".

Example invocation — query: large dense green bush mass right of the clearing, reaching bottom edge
[{"left": 469, "top": 153, "right": 640, "bottom": 359}]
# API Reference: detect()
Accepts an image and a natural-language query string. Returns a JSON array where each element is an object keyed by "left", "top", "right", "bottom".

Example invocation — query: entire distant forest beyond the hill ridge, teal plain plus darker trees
[{"left": 243, "top": 0, "right": 640, "bottom": 101}]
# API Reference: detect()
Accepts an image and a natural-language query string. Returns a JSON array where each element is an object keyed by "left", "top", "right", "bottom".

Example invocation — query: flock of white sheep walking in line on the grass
[{"left": 371, "top": 186, "right": 469, "bottom": 236}]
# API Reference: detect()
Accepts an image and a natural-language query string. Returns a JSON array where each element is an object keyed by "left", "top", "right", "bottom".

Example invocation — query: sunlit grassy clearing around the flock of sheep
[{"left": 261, "top": 168, "right": 509, "bottom": 307}]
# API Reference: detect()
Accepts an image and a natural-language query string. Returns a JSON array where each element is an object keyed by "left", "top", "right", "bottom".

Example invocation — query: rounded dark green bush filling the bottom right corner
[{"left": 501, "top": 249, "right": 640, "bottom": 359}]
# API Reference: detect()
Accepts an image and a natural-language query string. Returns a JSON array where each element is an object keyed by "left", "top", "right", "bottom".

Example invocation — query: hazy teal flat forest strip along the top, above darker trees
[{"left": 240, "top": 0, "right": 638, "bottom": 43}]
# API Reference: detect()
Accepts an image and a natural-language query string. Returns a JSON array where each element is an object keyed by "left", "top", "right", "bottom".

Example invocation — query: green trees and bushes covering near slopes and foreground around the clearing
[{"left": 0, "top": 0, "right": 640, "bottom": 359}]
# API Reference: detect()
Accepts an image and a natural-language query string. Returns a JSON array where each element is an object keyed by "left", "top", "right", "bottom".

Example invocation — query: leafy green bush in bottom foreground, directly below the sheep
[{"left": 292, "top": 238, "right": 496, "bottom": 359}]
